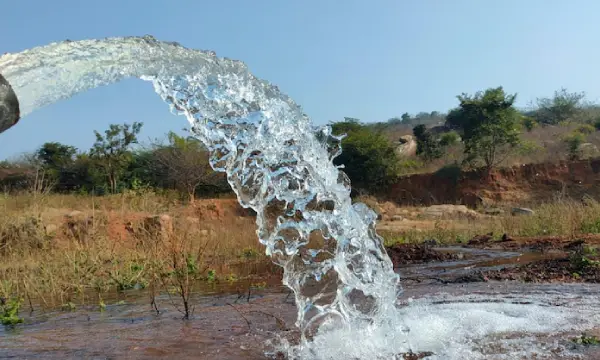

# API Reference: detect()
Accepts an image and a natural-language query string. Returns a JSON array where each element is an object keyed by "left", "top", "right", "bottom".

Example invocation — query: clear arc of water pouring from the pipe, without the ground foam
[{"left": 0, "top": 36, "right": 400, "bottom": 348}]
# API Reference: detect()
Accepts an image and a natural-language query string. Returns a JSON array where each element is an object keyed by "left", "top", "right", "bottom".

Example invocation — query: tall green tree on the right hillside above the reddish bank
[{"left": 447, "top": 87, "right": 521, "bottom": 172}]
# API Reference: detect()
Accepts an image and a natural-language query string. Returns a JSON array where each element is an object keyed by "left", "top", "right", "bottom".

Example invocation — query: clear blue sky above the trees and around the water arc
[{"left": 0, "top": 0, "right": 600, "bottom": 159}]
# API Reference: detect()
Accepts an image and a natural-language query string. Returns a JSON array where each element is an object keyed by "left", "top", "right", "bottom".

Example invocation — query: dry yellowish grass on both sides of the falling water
[{"left": 7, "top": 192, "right": 600, "bottom": 314}]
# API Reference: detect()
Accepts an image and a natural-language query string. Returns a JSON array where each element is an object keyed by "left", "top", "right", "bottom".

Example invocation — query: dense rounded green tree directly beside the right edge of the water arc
[{"left": 332, "top": 121, "right": 398, "bottom": 192}]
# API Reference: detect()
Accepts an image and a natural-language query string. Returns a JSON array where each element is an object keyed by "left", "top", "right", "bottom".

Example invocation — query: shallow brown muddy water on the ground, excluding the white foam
[{"left": 0, "top": 249, "right": 600, "bottom": 359}]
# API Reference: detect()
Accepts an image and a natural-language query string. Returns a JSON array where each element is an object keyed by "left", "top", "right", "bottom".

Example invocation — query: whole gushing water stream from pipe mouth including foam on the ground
[{"left": 0, "top": 36, "right": 599, "bottom": 359}]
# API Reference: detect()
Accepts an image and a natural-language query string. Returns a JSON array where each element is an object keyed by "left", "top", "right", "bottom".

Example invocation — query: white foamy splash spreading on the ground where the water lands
[{"left": 284, "top": 294, "right": 600, "bottom": 360}]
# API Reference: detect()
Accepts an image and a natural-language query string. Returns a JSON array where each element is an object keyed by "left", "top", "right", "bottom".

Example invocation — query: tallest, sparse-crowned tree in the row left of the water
[{"left": 90, "top": 122, "right": 143, "bottom": 193}]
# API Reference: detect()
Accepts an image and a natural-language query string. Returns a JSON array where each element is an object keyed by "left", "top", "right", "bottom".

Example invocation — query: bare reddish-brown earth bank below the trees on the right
[{"left": 381, "top": 159, "right": 600, "bottom": 208}]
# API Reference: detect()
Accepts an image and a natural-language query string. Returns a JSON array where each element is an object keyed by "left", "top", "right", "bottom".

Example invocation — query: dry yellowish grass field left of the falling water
[{"left": 0, "top": 192, "right": 277, "bottom": 314}]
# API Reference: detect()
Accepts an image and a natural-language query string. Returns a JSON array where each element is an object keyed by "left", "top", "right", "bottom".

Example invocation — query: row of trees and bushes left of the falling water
[{"left": 0, "top": 122, "right": 229, "bottom": 200}]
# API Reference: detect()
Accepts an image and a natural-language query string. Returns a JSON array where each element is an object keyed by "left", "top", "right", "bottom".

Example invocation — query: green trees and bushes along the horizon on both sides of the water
[{"left": 0, "top": 87, "right": 600, "bottom": 201}]
